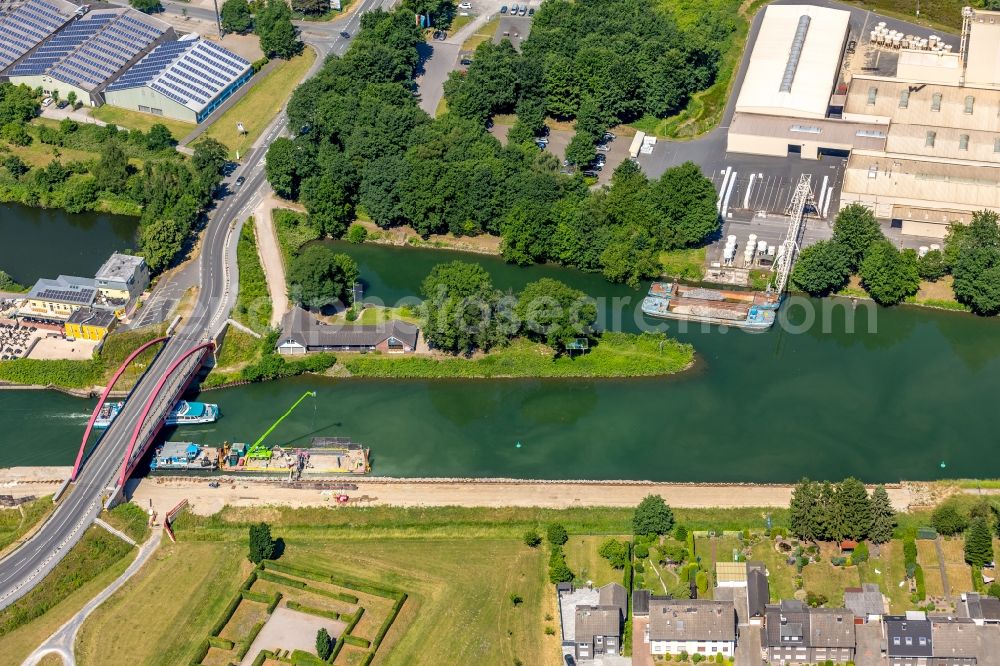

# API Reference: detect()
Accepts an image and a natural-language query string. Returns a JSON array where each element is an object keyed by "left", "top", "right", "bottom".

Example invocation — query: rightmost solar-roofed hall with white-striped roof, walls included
[{"left": 106, "top": 35, "right": 253, "bottom": 123}]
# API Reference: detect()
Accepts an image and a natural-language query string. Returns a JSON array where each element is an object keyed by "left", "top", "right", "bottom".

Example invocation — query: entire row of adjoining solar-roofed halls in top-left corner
[{"left": 0, "top": 0, "right": 253, "bottom": 123}]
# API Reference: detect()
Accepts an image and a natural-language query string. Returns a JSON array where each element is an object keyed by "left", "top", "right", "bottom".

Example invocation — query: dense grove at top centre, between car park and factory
[{"left": 445, "top": 0, "right": 737, "bottom": 164}]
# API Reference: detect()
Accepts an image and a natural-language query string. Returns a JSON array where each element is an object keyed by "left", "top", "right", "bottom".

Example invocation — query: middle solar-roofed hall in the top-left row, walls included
[{"left": 7, "top": 8, "right": 175, "bottom": 106}]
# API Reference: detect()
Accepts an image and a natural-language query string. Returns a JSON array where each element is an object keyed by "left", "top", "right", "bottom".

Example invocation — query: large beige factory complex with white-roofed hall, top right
[{"left": 727, "top": 5, "right": 1000, "bottom": 238}]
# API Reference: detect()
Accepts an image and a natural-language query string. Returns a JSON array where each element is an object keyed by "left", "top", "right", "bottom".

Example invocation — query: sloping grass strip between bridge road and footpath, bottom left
[{"left": 0, "top": 527, "right": 136, "bottom": 664}]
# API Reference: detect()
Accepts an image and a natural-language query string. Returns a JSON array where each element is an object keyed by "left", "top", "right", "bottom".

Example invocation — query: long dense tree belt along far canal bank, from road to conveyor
[{"left": 266, "top": 10, "right": 719, "bottom": 284}]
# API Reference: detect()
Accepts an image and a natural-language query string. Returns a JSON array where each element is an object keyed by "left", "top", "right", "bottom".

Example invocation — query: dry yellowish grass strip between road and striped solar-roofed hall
[{"left": 202, "top": 47, "right": 316, "bottom": 157}]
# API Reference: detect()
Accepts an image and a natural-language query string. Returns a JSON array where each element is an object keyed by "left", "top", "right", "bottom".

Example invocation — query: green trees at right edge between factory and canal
[{"left": 945, "top": 210, "right": 1000, "bottom": 315}]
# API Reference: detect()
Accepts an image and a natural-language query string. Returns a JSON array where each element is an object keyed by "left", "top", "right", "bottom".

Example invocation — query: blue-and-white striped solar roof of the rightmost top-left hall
[{"left": 108, "top": 39, "right": 251, "bottom": 111}]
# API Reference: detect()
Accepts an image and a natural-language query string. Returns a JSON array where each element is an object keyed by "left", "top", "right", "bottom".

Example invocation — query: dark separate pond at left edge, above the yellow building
[{"left": 0, "top": 198, "right": 139, "bottom": 284}]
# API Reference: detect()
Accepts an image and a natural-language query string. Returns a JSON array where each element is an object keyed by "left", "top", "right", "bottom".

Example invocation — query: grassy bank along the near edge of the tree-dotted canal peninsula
[{"left": 342, "top": 333, "right": 694, "bottom": 379}]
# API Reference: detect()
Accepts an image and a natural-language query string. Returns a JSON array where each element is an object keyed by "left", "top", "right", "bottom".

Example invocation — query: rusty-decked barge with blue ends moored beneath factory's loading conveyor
[{"left": 642, "top": 282, "right": 781, "bottom": 330}]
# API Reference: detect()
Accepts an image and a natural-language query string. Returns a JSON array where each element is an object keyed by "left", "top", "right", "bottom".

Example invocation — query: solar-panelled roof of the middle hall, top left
[{"left": 10, "top": 10, "right": 168, "bottom": 90}]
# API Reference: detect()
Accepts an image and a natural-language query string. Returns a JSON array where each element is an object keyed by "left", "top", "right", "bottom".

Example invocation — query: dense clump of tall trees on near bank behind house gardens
[{"left": 789, "top": 477, "right": 896, "bottom": 543}]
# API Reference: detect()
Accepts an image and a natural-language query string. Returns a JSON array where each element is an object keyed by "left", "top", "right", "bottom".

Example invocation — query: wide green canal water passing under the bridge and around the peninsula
[{"left": 0, "top": 244, "right": 1000, "bottom": 482}]
